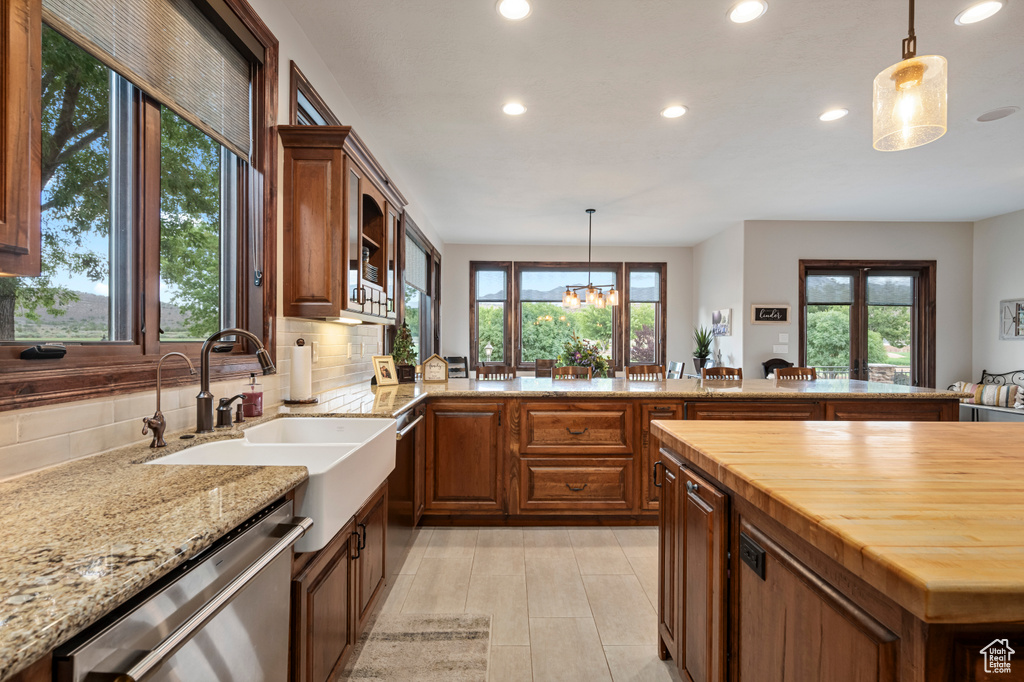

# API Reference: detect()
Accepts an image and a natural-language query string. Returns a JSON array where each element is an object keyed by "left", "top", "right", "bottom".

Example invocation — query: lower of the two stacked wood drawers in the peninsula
[{"left": 520, "top": 459, "right": 633, "bottom": 511}]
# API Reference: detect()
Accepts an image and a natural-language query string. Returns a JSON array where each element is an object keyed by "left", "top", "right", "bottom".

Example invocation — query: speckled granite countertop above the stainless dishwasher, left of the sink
[{"left": 0, "top": 418, "right": 307, "bottom": 680}]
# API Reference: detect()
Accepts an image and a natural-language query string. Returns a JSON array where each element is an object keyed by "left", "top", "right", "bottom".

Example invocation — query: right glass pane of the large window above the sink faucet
[{"left": 160, "top": 106, "right": 234, "bottom": 341}]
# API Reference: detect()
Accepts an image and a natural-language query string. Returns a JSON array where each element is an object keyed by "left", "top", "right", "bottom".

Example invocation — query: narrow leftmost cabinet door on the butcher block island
[{"left": 654, "top": 451, "right": 683, "bottom": 660}]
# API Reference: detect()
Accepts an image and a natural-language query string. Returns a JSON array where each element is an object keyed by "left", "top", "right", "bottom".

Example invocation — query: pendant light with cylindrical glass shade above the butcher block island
[{"left": 871, "top": 0, "right": 946, "bottom": 152}]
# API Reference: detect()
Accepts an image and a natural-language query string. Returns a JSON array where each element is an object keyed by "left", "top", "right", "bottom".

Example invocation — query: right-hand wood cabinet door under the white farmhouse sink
[{"left": 355, "top": 480, "right": 387, "bottom": 632}]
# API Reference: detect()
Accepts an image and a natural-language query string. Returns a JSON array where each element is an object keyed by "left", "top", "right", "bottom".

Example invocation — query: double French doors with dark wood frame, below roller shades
[{"left": 800, "top": 260, "right": 935, "bottom": 386}]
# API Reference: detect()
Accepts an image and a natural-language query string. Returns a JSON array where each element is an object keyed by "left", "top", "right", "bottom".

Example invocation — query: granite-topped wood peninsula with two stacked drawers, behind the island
[{"left": 403, "top": 377, "right": 959, "bottom": 524}]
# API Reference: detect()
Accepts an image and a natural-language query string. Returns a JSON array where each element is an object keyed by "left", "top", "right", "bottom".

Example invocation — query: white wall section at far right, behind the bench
[{"left": 958, "top": 206, "right": 1024, "bottom": 381}]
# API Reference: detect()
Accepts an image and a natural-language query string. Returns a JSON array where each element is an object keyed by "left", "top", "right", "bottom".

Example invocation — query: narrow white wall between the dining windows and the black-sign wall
[{"left": 684, "top": 224, "right": 745, "bottom": 368}]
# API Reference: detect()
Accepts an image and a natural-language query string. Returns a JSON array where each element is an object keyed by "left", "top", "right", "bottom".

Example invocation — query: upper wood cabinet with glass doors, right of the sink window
[{"left": 279, "top": 126, "right": 406, "bottom": 321}]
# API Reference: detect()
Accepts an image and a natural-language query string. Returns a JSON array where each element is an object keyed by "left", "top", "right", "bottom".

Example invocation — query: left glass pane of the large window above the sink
[{"left": 0, "top": 25, "right": 133, "bottom": 342}]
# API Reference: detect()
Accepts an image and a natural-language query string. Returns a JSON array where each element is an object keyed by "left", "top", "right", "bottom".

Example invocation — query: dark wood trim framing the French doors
[{"left": 797, "top": 259, "right": 937, "bottom": 388}]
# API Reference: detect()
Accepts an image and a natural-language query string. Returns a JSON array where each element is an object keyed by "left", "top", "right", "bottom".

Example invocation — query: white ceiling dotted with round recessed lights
[{"left": 289, "top": 0, "right": 1024, "bottom": 245}]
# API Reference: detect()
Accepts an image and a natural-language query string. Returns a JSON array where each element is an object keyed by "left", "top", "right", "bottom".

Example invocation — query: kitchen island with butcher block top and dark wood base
[{"left": 651, "top": 421, "right": 1024, "bottom": 682}]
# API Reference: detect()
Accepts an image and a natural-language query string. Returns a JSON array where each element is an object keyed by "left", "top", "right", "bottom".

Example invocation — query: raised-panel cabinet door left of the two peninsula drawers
[{"left": 426, "top": 401, "right": 506, "bottom": 512}]
